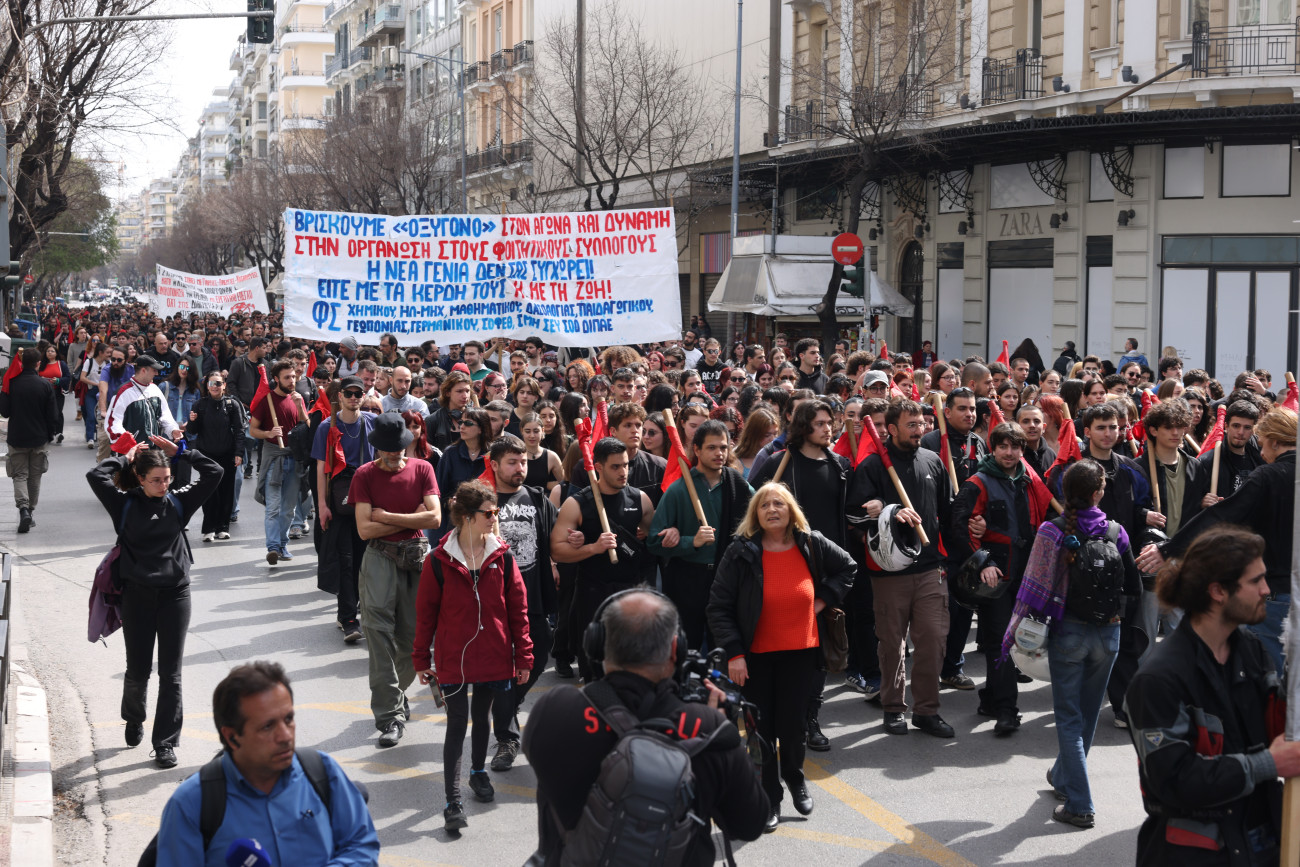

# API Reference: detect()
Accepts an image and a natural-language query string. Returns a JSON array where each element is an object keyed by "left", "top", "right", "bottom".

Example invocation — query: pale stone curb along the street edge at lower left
[{"left": 9, "top": 660, "right": 55, "bottom": 867}]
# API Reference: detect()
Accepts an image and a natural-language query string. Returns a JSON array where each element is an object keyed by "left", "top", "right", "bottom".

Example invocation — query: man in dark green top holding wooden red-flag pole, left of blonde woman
[{"left": 649, "top": 409, "right": 754, "bottom": 647}]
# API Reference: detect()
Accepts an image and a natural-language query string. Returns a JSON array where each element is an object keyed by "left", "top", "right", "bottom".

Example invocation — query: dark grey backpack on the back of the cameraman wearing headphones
[{"left": 555, "top": 681, "right": 738, "bottom": 867}]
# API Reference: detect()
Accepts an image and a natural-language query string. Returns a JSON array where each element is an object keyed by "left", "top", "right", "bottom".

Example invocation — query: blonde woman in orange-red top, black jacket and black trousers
[{"left": 709, "top": 484, "right": 858, "bottom": 831}]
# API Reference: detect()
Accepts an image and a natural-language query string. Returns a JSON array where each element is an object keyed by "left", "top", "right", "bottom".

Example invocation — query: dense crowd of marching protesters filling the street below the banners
[{"left": 5, "top": 298, "right": 1296, "bottom": 863}]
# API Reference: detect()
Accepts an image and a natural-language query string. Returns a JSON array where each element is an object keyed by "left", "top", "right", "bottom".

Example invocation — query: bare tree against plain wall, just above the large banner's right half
[{"left": 508, "top": 3, "right": 725, "bottom": 211}]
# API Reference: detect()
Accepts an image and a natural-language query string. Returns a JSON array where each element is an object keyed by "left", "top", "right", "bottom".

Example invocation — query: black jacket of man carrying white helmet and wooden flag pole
[{"left": 848, "top": 439, "right": 953, "bottom": 575}]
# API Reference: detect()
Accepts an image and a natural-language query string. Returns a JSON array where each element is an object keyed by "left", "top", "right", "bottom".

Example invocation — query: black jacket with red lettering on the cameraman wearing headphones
[{"left": 524, "top": 671, "right": 768, "bottom": 867}]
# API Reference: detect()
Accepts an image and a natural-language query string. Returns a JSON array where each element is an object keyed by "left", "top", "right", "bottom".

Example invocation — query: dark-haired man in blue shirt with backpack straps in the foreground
[{"left": 157, "top": 662, "right": 380, "bottom": 867}]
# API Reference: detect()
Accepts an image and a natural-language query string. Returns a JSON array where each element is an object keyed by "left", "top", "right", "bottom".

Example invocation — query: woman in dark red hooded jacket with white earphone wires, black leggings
[{"left": 411, "top": 480, "right": 533, "bottom": 831}]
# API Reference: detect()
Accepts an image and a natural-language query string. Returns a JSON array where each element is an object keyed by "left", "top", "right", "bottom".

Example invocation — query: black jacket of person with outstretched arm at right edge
[{"left": 1160, "top": 451, "right": 1296, "bottom": 582}]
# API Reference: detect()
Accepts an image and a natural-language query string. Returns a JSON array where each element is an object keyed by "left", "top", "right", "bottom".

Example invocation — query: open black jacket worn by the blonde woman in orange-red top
[{"left": 707, "top": 530, "right": 858, "bottom": 659}]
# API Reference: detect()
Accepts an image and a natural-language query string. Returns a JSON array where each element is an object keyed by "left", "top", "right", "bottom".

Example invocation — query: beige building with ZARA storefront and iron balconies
[{"left": 712, "top": 0, "right": 1300, "bottom": 376}]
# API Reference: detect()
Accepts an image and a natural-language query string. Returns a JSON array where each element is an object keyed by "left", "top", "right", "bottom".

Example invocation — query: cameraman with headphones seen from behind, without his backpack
[{"left": 524, "top": 590, "right": 768, "bottom": 864}]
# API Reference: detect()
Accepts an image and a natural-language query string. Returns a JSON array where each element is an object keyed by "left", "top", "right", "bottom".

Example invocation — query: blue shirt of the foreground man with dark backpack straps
[{"left": 157, "top": 753, "right": 380, "bottom": 867}]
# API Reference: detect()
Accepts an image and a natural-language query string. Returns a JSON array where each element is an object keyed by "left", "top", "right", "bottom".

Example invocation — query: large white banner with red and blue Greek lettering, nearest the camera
[{"left": 285, "top": 208, "right": 681, "bottom": 347}]
